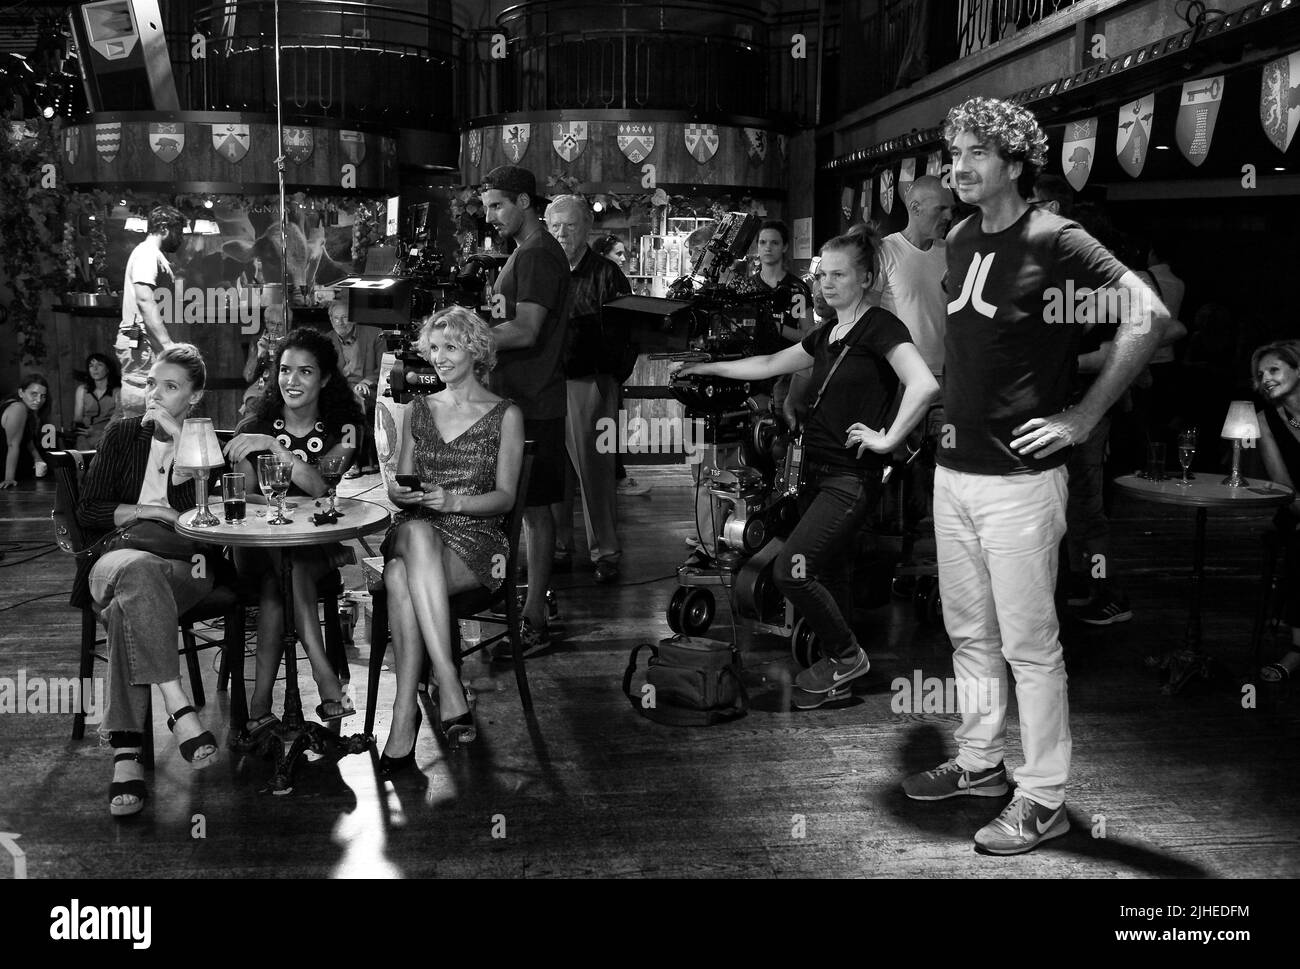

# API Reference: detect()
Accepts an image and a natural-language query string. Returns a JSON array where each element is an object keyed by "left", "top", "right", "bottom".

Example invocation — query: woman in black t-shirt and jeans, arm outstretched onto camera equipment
[{"left": 679, "top": 233, "right": 939, "bottom": 710}]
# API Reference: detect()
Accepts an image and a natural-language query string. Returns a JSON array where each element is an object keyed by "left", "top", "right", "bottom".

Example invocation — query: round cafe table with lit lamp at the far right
[{"left": 1115, "top": 471, "right": 1295, "bottom": 695}]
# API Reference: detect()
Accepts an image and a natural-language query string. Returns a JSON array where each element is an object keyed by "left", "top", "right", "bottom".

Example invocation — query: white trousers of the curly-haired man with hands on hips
[{"left": 935, "top": 467, "right": 1071, "bottom": 809}]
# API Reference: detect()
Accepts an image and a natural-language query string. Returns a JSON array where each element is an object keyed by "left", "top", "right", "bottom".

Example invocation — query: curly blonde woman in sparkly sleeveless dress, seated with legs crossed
[{"left": 380, "top": 307, "right": 524, "bottom": 774}]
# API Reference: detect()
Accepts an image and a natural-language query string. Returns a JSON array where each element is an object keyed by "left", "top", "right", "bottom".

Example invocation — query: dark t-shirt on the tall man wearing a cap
[{"left": 491, "top": 226, "right": 569, "bottom": 420}]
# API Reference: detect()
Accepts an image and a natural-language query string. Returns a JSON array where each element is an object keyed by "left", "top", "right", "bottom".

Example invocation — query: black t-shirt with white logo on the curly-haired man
[{"left": 936, "top": 208, "right": 1126, "bottom": 475}]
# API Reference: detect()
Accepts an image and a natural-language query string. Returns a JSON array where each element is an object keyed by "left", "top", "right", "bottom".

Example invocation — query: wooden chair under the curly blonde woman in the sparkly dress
[{"left": 365, "top": 441, "right": 536, "bottom": 734}]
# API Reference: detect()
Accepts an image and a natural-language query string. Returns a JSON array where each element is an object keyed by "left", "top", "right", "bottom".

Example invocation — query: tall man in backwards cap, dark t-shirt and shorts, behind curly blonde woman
[{"left": 481, "top": 165, "right": 569, "bottom": 658}]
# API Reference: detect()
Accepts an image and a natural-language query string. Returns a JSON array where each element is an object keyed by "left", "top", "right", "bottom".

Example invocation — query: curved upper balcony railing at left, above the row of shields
[{"left": 187, "top": 0, "right": 465, "bottom": 130}]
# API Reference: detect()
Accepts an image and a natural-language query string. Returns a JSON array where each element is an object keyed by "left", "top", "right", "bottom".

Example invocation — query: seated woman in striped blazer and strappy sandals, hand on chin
[{"left": 73, "top": 343, "right": 221, "bottom": 817}]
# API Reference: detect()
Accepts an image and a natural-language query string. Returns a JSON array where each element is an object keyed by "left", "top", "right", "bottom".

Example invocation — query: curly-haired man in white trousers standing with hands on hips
[{"left": 904, "top": 98, "right": 1167, "bottom": 855}]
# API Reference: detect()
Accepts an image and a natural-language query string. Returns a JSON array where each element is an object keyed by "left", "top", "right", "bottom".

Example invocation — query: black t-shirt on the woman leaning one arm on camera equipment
[{"left": 802, "top": 306, "right": 911, "bottom": 471}]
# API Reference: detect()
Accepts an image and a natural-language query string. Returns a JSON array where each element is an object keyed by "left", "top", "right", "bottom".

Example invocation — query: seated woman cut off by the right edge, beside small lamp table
[{"left": 1251, "top": 339, "right": 1300, "bottom": 683}]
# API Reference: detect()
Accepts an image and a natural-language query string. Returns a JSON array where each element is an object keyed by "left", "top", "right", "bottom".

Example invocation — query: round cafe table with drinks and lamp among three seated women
[{"left": 176, "top": 497, "right": 389, "bottom": 795}]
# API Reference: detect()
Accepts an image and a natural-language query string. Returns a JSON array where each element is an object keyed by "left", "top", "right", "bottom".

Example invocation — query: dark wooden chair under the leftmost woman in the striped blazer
[{"left": 48, "top": 451, "right": 248, "bottom": 767}]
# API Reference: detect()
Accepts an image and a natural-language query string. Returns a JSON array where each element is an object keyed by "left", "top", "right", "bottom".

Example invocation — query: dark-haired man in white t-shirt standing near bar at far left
[{"left": 111, "top": 206, "right": 189, "bottom": 423}]
